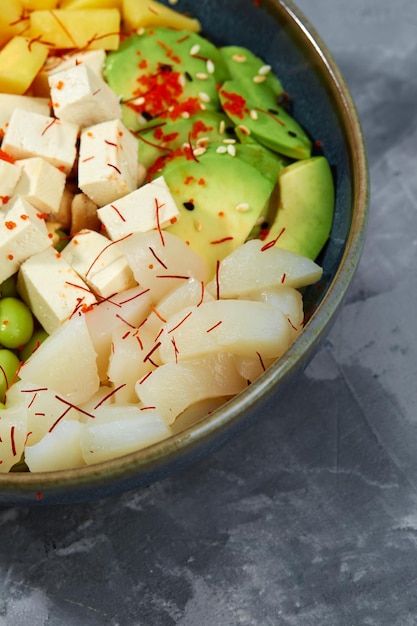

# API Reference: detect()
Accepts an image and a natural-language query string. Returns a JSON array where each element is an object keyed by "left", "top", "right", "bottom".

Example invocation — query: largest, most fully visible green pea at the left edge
[{"left": 0, "top": 298, "right": 34, "bottom": 348}]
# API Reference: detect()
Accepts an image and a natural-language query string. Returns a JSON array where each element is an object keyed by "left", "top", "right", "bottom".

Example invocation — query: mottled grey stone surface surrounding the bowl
[{"left": 0, "top": 0, "right": 417, "bottom": 626}]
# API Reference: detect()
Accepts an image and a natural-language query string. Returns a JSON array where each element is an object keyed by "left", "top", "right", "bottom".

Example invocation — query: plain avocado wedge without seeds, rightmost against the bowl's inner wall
[{"left": 268, "top": 156, "right": 334, "bottom": 260}]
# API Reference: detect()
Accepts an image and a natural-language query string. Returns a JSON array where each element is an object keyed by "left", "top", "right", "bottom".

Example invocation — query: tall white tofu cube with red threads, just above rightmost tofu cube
[{"left": 78, "top": 120, "right": 139, "bottom": 206}]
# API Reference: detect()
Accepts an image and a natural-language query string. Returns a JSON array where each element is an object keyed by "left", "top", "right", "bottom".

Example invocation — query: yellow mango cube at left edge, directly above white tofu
[{"left": 0, "top": 36, "right": 48, "bottom": 95}]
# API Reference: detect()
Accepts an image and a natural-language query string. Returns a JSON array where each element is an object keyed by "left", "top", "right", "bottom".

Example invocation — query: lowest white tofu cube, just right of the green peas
[{"left": 17, "top": 246, "right": 96, "bottom": 334}]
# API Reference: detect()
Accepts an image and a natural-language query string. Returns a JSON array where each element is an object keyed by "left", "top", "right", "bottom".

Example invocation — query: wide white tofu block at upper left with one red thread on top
[{"left": 2, "top": 109, "right": 79, "bottom": 174}]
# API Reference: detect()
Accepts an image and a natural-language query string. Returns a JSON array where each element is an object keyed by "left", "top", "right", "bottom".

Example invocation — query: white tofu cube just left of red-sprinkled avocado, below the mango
[{"left": 49, "top": 63, "right": 122, "bottom": 128}]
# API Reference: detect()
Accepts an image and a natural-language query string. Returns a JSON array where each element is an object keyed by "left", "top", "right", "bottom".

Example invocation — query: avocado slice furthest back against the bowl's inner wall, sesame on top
[{"left": 220, "top": 46, "right": 284, "bottom": 97}]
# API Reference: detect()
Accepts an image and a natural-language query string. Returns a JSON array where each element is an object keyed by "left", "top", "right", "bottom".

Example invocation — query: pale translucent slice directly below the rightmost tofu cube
[{"left": 115, "top": 230, "right": 208, "bottom": 303}]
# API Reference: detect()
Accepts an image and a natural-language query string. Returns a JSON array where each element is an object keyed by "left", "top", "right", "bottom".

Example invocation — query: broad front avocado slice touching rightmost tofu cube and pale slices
[{"left": 163, "top": 151, "right": 274, "bottom": 274}]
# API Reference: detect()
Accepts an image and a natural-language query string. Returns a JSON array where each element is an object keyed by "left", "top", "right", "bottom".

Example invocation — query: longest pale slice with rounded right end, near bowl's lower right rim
[{"left": 159, "top": 300, "right": 291, "bottom": 363}]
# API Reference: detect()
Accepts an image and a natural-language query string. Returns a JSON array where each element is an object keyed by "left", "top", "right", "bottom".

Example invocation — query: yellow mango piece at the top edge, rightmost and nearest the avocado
[{"left": 122, "top": 0, "right": 201, "bottom": 32}]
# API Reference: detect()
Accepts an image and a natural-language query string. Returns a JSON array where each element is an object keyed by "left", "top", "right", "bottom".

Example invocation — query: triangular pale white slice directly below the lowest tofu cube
[{"left": 19, "top": 314, "right": 100, "bottom": 404}]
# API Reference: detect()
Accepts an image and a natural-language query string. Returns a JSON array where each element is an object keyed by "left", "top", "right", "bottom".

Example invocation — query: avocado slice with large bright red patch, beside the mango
[{"left": 104, "top": 27, "right": 229, "bottom": 131}]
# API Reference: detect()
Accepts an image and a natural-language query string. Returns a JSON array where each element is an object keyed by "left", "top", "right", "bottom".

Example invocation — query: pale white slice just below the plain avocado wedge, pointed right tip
[{"left": 207, "top": 239, "right": 323, "bottom": 298}]
